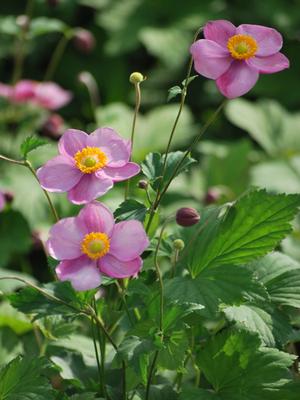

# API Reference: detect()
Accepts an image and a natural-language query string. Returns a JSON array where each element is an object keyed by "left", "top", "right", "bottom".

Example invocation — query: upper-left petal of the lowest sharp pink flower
[{"left": 46, "top": 217, "right": 87, "bottom": 260}]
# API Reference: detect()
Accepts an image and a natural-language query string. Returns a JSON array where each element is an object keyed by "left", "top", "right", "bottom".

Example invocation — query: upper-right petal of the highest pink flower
[{"left": 236, "top": 24, "right": 282, "bottom": 57}]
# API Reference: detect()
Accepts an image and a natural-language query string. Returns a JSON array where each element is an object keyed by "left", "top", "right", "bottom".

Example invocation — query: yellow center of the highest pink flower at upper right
[{"left": 227, "top": 35, "right": 258, "bottom": 60}]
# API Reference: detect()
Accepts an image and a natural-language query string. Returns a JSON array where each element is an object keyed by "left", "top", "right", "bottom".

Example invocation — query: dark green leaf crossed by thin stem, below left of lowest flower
[{"left": 8, "top": 281, "right": 84, "bottom": 319}]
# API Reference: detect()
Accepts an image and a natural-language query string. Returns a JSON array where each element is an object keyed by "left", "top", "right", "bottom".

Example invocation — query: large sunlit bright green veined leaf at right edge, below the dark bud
[{"left": 187, "top": 190, "right": 300, "bottom": 276}]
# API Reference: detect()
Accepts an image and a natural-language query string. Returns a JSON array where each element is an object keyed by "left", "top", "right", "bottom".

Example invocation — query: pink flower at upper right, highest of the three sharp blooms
[{"left": 191, "top": 20, "right": 289, "bottom": 99}]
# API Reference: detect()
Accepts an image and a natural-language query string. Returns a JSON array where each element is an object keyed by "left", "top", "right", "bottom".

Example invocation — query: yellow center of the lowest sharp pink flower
[{"left": 81, "top": 232, "right": 110, "bottom": 260}]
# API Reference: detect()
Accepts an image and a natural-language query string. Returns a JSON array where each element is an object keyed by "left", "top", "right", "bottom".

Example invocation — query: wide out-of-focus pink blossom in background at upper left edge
[{"left": 0, "top": 80, "right": 72, "bottom": 110}]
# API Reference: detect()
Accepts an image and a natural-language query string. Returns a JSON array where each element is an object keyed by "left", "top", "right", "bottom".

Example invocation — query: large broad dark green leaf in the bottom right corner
[{"left": 180, "top": 330, "right": 296, "bottom": 400}]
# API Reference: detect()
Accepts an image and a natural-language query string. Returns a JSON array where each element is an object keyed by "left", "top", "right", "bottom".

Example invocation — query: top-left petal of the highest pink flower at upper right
[{"left": 204, "top": 19, "right": 236, "bottom": 49}]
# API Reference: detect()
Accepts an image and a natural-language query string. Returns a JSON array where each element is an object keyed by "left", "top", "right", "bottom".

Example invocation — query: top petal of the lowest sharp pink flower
[{"left": 78, "top": 201, "right": 115, "bottom": 236}]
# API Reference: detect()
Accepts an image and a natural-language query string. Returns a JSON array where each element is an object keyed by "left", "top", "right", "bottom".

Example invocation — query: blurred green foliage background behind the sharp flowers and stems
[{"left": 0, "top": 0, "right": 300, "bottom": 280}]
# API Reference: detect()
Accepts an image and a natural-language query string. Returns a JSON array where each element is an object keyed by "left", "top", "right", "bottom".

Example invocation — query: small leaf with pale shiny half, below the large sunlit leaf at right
[{"left": 223, "top": 303, "right": 293, "bottom": 347}]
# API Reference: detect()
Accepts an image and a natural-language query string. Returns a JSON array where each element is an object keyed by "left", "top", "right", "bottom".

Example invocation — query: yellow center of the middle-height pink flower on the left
[{"left": 74, "top": 146, "right": 108, "bottom": 174}]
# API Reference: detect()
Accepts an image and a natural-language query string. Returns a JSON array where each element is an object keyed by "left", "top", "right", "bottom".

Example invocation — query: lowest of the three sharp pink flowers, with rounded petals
[{"left": 46, "top": 201, "right": 149, "bottom": 290}]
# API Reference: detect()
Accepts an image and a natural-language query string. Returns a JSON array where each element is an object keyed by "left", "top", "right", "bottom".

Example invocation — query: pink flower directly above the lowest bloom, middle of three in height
[{"left": 37, "top": 128, "right": 140, "bottom": 204}]
